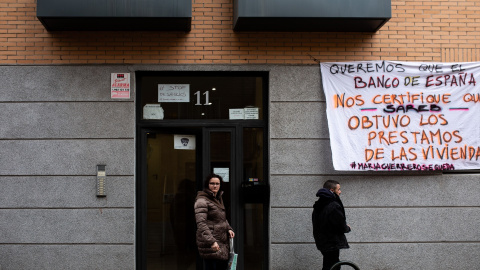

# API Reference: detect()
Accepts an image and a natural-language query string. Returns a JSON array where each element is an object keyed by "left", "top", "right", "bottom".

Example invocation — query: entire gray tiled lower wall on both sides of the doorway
[{"left": 0, "top": 65, "right": 480, "bottom": 270}]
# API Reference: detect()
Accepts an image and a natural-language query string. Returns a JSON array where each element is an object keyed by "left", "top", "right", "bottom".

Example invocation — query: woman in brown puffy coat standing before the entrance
[{"left": 195, "top": 174, "right": 235, "bottom": 270}]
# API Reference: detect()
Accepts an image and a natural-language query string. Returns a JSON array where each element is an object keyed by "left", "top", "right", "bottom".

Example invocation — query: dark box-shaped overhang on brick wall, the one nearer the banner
[{"left": 233, "top": 0, "right": 392, "bottom": 32}]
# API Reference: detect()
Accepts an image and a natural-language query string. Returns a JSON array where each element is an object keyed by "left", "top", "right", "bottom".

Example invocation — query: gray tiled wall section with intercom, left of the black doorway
[{"left": 0, "top": 66, "right": 135, "bottom": 270}]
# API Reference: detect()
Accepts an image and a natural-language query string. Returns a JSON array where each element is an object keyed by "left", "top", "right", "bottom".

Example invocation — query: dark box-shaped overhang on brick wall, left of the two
[{"left": 37, "top": 0, "right": 192, "bottom": 31}]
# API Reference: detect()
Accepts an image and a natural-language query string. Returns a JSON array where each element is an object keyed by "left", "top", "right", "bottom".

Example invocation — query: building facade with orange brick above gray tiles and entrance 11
[{"left": 0, "top": 0, "right": 480, "bottom": 270}]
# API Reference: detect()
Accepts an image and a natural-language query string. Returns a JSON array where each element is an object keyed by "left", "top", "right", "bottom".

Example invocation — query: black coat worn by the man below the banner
[{"left": 312, "top": 188, "right": 350, "bottom": 251}]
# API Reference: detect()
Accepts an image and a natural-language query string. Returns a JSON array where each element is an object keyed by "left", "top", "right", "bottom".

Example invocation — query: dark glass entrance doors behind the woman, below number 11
[{"left": 136, "top": 70, "right": 269, "bottom": 270}]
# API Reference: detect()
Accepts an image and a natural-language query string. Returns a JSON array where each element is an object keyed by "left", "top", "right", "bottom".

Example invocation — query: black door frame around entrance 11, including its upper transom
[{"left": 135, "top": 70, "right": 270, "bottom": 270}]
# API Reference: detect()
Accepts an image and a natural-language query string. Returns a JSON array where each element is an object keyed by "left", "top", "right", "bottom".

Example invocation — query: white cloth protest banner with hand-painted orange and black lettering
[{"left": 320, "top": 61, "right": 480, "bottom": 171}]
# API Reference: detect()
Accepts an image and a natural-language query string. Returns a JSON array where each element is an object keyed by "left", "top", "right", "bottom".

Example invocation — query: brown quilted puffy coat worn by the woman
[{"left": 195, "top": 189, "right": 233, "bottom": 260}]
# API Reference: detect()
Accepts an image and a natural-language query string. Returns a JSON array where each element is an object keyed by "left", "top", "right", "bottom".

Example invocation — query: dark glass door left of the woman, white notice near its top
[{"left": 144, "top": 129, "right": 202, "bottom": 270}]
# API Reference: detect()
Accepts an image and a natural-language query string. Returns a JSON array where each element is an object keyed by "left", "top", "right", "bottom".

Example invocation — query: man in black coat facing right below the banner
[{"left": 312, "top": 180, "right": 350, "bottom": 270}]
